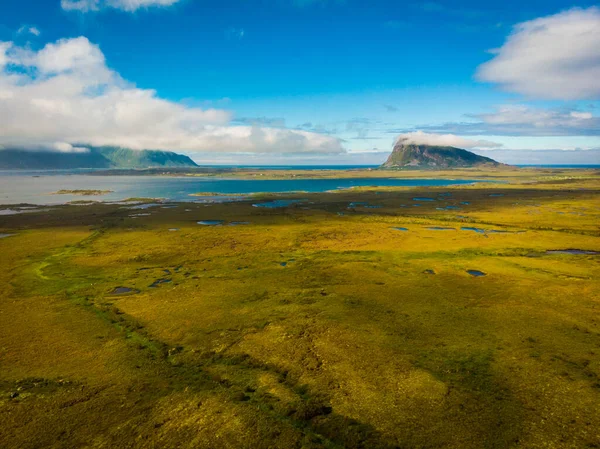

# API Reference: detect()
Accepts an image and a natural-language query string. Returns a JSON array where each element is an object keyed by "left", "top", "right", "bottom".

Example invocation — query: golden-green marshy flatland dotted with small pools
[{"left": 0, "top": 170, "right": 600, "bottom": 449}]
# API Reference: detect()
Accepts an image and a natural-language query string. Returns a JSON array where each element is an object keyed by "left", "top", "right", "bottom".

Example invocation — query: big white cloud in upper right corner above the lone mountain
[{"left": 476, "top": 7, "right": 600, "bottom": 100}]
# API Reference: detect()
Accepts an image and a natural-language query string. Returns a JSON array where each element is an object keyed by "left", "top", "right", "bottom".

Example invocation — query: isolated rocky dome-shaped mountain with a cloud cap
[{"left": 381, "top": 140, "right": 503, "bottom": 168}]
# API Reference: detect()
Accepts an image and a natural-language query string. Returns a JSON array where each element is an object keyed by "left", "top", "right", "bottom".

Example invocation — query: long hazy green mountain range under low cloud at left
[{"left": 0, "top": 147, "right": 197, "bottom": 170}]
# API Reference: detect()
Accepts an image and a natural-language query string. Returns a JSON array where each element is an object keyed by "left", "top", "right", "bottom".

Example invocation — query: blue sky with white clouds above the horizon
[{"left": 0, "top": 0, "right": 600, "bottom": 163}]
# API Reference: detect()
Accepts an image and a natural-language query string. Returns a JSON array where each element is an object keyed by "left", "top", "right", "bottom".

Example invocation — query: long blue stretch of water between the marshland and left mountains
[{"left": 0, "top": 173, "right": 485, "bottom": 204}]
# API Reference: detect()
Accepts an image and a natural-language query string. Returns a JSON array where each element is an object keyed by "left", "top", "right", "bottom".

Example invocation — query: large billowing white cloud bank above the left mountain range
[{"left": 0, "top": 37, "right": 344, "bottom": 153}]
